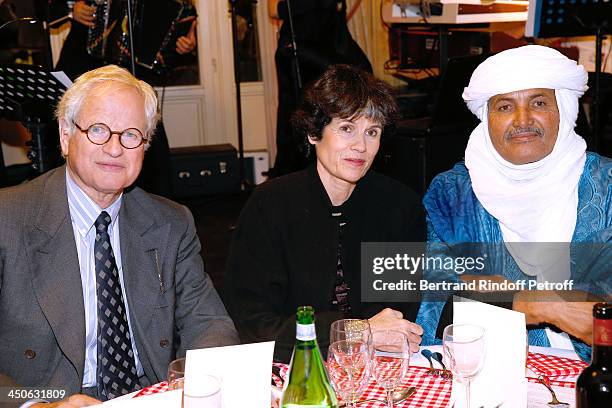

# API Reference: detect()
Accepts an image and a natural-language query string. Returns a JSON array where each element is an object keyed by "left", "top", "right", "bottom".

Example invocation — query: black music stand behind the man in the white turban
[{"left": 525, "top": 0, "right": 612, "bottom": 151}]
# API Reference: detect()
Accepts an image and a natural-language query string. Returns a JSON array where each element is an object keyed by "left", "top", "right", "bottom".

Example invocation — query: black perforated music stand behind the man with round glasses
[{"left": 0, "top": 64, "right": 66, "bottom": 174}]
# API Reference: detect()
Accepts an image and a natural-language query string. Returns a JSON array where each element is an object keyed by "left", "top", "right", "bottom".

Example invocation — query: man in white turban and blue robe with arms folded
[{"left": 417, "top": 45, "right": 612, "bottom": 357}]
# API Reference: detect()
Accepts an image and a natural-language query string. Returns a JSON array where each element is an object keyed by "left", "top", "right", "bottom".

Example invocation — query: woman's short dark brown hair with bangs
[{"left": 291, "top": 65, "right": 397, "bottom": 151}]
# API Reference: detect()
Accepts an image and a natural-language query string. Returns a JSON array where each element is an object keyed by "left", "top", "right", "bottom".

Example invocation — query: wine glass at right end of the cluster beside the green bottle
[{"left": 372, "top": 330, "right": 410, "bottom": 408}]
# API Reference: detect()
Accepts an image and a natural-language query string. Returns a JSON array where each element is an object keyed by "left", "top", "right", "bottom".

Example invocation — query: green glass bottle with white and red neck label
[{"left": 281, "top": 306, "right": 338, "bottom": 408}]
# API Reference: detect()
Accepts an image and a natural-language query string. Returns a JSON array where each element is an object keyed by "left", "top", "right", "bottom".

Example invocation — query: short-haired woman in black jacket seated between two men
[{"left": 224, "top": 65, "right": 425, "bottom": 361}]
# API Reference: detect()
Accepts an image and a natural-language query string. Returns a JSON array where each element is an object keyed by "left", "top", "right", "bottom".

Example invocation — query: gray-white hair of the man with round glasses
[{"left": 55, "top": 65, "right": 159, "bottom": 146}]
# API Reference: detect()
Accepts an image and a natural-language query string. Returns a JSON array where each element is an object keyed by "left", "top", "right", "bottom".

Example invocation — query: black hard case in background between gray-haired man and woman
[{"left": 170, "top": 144, "right": 240, "bottom": 198}]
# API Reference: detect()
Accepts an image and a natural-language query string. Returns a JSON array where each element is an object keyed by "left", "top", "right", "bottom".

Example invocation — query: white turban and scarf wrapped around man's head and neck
[{"left": 463, "top": 45, "right": 588, "bottom": 286}]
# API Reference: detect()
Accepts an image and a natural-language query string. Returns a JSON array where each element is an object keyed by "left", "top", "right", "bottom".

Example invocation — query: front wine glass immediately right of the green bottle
[{"left": 327, "top": 340, "right": 371, "bottom": 407}]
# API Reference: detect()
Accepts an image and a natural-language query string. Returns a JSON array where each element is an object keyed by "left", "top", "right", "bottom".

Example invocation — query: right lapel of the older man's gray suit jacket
[{"left": 119, "top": 191, "right": 173, "bottom": 381}]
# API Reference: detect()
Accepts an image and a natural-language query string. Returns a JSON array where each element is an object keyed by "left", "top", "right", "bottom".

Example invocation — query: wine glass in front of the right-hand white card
[{"left": 442, "top": 324, "right": 485, "bottom": 408}]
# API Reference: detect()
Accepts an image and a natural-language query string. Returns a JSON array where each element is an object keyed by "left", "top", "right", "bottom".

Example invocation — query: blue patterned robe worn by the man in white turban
[{"left": 417, "top": 153, "right": 612, "bottom": 360}]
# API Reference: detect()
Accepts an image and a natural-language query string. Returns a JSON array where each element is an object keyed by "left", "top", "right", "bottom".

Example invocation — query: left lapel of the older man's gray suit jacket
[{"left": 28, "top": 168, "right": 85, "bottom": 386}]
